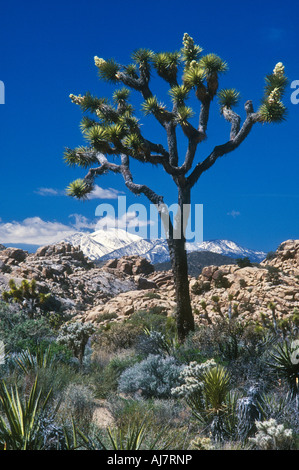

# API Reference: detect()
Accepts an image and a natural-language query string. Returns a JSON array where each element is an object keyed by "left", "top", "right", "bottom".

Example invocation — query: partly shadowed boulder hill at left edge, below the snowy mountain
[{"left": 0, "top": 243, "right": 153, "bottom": 314}]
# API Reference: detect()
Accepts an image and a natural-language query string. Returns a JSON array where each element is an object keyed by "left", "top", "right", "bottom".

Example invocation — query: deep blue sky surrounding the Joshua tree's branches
[{"left": 0, "top": 0, "right": 299, "bottom": 251}]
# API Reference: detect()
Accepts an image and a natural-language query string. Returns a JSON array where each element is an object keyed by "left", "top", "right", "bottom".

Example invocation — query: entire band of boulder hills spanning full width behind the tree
[{"left": 0, "top": 240, "right": 299, "bottom": 330}]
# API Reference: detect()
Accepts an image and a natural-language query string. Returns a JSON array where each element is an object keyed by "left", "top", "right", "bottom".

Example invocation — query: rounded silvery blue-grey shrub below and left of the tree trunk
[{"left": 118, "top": 354, "right": 182, "bottom": 398}]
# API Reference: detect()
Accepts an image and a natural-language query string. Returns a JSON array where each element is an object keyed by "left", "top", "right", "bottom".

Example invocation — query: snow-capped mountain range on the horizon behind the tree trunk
[{"left": 63, "top": 229, "right": 266, "bottom": 264}]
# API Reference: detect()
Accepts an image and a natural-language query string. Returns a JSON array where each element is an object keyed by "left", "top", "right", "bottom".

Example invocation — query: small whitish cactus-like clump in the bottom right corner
[{"left": 250, "top": 419, "right": 293, "bottom": 450}]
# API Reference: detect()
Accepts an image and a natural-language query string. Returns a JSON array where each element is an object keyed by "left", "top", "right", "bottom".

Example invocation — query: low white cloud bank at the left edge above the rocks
[{"left": 0, "top": 217, "right": 77, "bottom": 245}]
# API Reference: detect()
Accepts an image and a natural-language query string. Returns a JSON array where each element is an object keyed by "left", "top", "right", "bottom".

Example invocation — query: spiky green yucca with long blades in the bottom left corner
[{"left": 0, "top": 377, "right": 51, "bottom": 450}]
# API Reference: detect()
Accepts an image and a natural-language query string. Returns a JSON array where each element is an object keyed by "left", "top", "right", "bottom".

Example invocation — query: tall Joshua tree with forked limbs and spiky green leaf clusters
[{"left": 64, "top": 33, "right": 287, "bottom": 341}]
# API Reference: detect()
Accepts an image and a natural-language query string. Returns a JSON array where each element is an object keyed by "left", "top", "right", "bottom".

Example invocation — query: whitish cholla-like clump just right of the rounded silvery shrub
[{"left": 171, "top": 359, "right": 216, "bottom": 398}]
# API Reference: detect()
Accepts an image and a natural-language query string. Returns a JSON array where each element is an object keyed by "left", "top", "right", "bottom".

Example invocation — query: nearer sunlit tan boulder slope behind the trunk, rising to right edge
[{"left": 85, "top": 240, "right": 299, "bottom": 322}]
